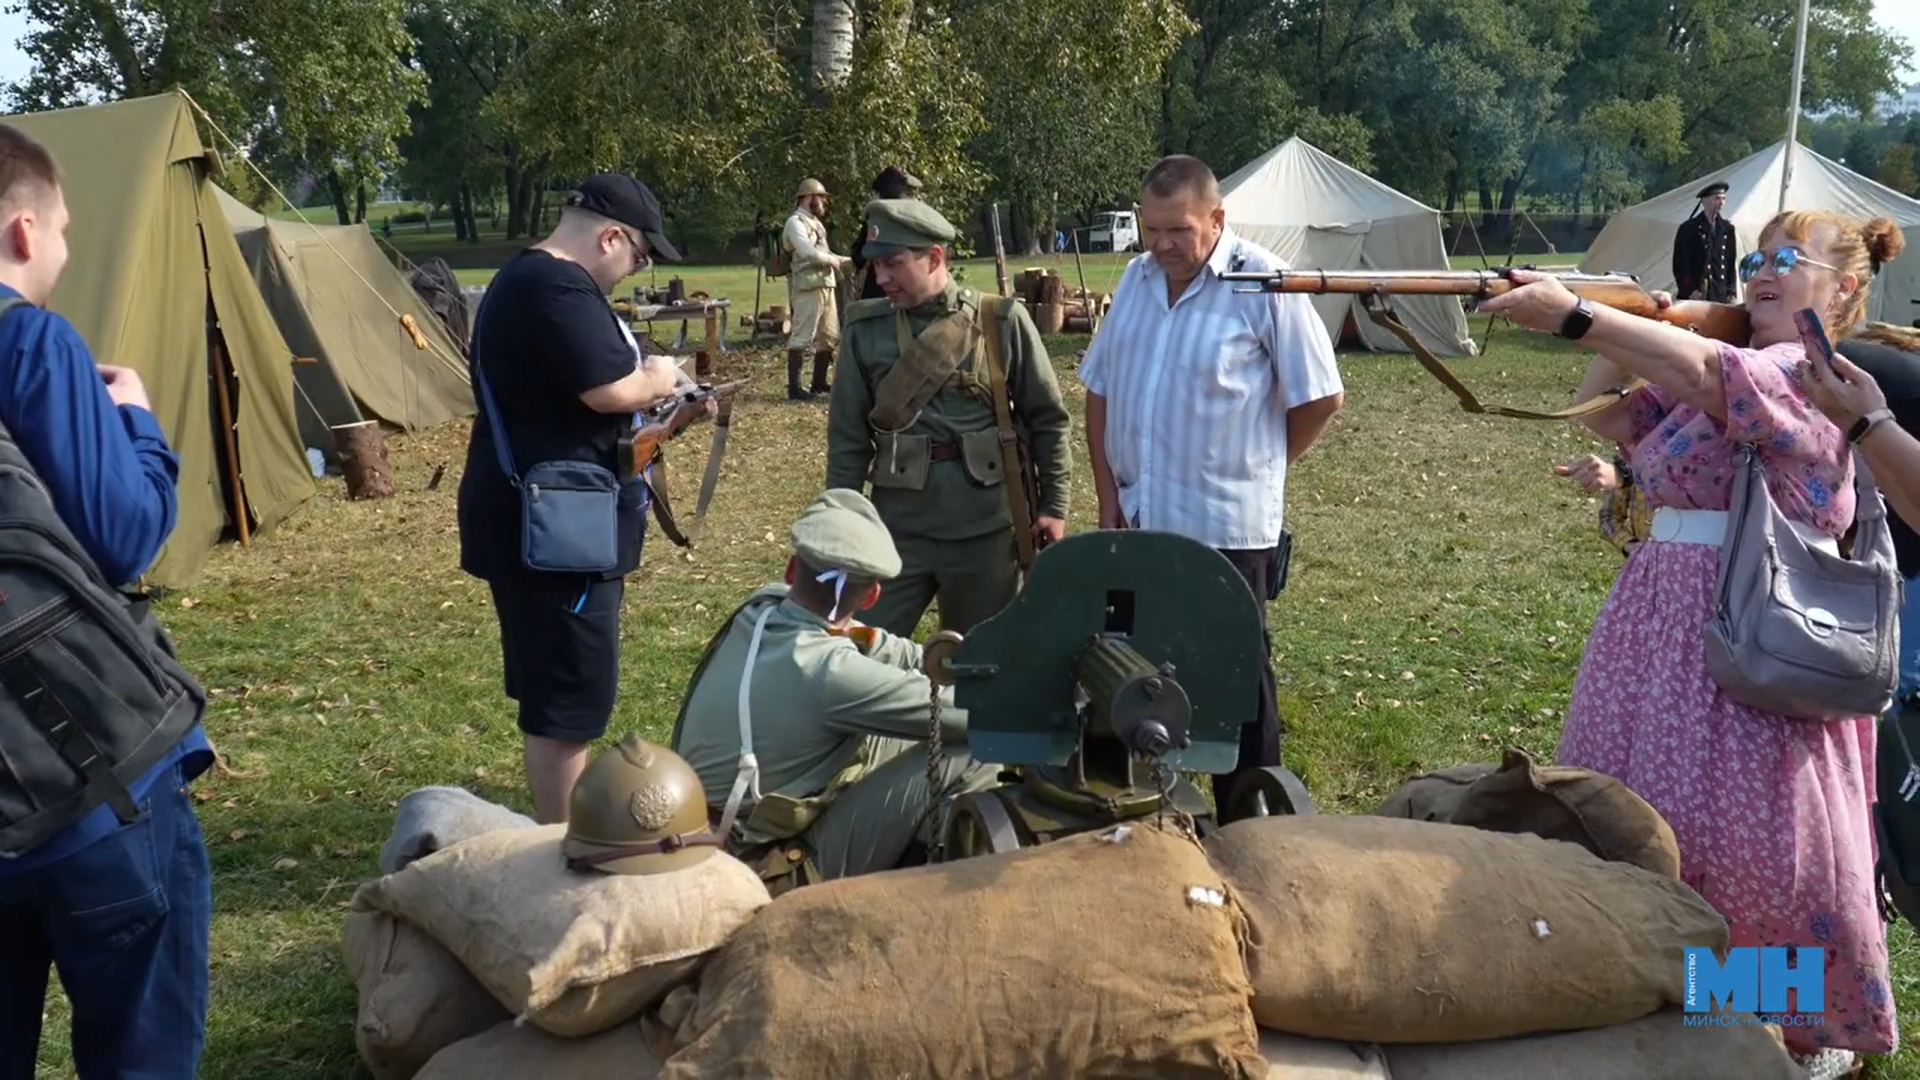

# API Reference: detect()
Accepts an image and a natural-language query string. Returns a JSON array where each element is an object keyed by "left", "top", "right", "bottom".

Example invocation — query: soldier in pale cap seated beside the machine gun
[{"left": 672, "top": 488, "right": 998, "bottom": 888}]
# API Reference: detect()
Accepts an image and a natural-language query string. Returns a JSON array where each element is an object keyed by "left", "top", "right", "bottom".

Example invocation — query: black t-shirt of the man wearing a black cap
[{"left": 459, "top": 248, "right": 645, "bottom": 578}]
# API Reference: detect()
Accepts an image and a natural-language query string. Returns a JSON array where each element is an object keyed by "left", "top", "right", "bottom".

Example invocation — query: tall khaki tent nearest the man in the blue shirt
[{"left": 6, "top": 92, "right": 317, "bottom": 584}]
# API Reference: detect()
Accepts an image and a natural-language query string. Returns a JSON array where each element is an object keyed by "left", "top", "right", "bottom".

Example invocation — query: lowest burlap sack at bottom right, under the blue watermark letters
[{"left": 1386, "top": 1009, "right": 1807, "bottom": 1080}]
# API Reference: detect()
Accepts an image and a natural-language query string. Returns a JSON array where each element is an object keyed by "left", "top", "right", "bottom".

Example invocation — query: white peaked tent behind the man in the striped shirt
[{"left": 1219, "top": 135, "right": 1475, "bottom": 356}]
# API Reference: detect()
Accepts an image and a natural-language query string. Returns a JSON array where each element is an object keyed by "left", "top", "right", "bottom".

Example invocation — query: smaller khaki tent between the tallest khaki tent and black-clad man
[{"left": 215, "top": 188, "right": 474, "bottom": 452}]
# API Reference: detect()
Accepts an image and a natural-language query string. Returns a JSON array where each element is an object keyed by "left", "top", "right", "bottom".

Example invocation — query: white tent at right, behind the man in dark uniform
[{"left": 1580, "top": 140, "right": 1920, "bottom": 327}]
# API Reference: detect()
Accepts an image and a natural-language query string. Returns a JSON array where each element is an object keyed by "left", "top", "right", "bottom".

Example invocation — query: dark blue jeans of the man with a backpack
[{"left": 0, "top": 765, "right": 213, "bottom": 1080}]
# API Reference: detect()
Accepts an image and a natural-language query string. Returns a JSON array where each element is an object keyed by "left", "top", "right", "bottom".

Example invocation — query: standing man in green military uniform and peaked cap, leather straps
[{"left": 828, "top": 198, "right": 1071, "bottom": 636}]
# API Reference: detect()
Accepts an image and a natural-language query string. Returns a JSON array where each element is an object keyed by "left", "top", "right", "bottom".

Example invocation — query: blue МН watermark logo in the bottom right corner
[{"left": 1682, "top": 945, "right": 1826, "bottom": 1028}]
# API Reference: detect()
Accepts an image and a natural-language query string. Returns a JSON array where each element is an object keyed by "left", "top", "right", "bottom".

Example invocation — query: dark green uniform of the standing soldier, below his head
[{"left": 828, "top": 282, "right": 1071, "bottom": 636}]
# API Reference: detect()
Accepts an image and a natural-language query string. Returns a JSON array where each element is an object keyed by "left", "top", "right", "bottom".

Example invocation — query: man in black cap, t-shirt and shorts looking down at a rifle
[{"left": 459, "top": 173, "right": 714, "bottom": 822}]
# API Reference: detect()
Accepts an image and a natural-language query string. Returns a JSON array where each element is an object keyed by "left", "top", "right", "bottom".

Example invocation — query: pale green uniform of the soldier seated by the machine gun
[{"left": 674, "top": 586, "right": 998, "bottom": 878}]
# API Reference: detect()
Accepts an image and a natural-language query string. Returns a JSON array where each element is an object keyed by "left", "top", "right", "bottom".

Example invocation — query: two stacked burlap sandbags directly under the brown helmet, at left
[{"left": 346, "top": 824, "right": 768, "bottom": 1080}]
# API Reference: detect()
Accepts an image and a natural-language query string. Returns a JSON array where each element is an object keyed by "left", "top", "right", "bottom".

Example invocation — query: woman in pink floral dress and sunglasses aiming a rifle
[{"left": 1484, "top": 211, "right": 1903, "bottom": 1076}]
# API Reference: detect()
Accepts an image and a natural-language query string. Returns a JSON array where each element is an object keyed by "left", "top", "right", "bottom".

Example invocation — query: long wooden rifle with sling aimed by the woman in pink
[{"left": 1221, "top": 267, "right": 1749, "bottom": 421}]
